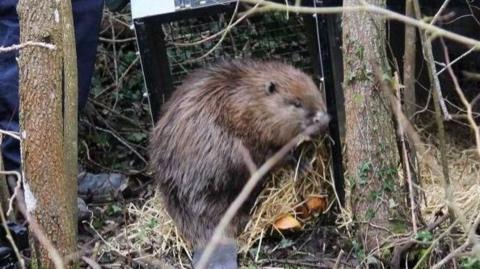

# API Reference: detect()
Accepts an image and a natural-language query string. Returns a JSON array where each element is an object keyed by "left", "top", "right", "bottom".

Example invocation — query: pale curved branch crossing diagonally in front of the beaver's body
[{"left": 197, "top": 125, "right": 319, "bottom": 269}]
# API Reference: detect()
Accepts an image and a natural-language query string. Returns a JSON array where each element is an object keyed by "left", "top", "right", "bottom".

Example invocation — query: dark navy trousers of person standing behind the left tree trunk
[{"left": 0, "top": 0, "right": 103, "bottom": 170}]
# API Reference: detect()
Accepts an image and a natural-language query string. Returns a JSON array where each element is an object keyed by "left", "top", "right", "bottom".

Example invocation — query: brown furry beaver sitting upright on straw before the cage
[{"left": 149, "top": 59, "right": 329, "bottom": 268}]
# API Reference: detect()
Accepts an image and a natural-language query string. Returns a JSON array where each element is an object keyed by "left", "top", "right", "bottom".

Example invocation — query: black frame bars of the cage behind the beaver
[{"left": 133, "top": 0, "right": 345, "bottom": 206}]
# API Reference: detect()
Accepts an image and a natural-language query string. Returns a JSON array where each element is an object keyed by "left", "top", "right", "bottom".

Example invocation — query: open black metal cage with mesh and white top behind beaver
[{"left": 131, "top": 0, "right": 344, "bottom": 203}]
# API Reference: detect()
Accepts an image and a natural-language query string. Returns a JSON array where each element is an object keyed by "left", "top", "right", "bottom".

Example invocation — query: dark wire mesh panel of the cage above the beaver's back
[{"left": 162, "top": 10, "right": 313, "bottom": 85}]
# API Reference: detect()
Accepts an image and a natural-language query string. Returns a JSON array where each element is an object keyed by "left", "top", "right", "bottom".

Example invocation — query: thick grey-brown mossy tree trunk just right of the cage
[{"left": 343, "top": 0, "right": 409, "bottom": 253}]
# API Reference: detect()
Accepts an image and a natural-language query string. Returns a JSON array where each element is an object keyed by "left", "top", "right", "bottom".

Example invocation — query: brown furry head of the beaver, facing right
[{"left": 226, "top": 62, "right": 330, "bottom": 145}]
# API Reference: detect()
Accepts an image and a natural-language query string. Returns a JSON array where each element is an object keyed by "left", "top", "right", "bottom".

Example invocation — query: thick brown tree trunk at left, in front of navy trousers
[{"left": 17, "top": 0, "right": 76, "bottom": 268}]
